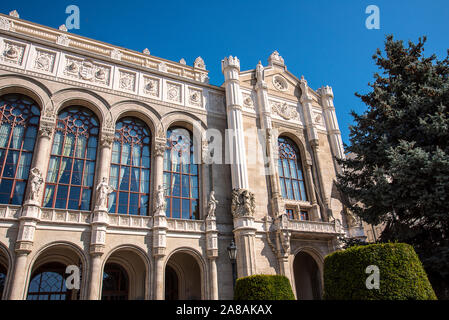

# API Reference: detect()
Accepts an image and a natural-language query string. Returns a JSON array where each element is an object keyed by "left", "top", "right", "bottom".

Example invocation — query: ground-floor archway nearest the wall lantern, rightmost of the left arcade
[{"left": 165, "top": 251, "right": 203, "bottom": 300}]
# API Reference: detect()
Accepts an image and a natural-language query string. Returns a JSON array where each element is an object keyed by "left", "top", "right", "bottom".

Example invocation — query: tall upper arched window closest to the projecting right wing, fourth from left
[{"left": 164, "top": 127, "right": 199, "bottom": 219}]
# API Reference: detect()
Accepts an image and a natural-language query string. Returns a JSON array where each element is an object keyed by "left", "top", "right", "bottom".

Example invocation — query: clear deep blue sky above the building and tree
[{"left": 0, "top": 0, "right": 449, "bottom": 143}]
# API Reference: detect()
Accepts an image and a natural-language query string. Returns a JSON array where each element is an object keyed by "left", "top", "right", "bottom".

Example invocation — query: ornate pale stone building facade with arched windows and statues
[{"left": 0, "top": 11, "right": 363, "bottom": 300}]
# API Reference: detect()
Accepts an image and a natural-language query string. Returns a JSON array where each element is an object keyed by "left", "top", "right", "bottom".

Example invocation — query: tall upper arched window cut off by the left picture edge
[{"left": 0, "top": 94, "right": 40, "bottom": 205}]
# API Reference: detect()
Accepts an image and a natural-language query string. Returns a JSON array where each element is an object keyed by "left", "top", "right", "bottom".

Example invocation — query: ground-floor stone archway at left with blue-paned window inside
[{"left": 27, "top": 244, "right": 83, "bottom": 300}]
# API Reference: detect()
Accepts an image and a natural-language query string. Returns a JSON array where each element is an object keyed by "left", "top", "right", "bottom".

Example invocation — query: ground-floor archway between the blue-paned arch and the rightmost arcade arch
[{"left": 101, "top": 247, "right": 148, "bottom": 300}]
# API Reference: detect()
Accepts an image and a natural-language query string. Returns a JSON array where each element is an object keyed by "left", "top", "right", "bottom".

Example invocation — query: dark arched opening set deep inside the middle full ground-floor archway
[{"left": 101, "top": 263, "right": 129, "bottom": 300}]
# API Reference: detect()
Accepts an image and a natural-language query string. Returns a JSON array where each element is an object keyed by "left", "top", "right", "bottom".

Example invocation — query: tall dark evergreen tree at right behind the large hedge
[{"left": 337, "top": 36, "right": 449, "bottom": 298}]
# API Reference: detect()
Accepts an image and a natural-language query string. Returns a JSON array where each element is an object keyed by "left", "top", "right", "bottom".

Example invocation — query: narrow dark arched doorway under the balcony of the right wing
[{"left": 293, "top": 251, "right": 321, "bottom": 300}]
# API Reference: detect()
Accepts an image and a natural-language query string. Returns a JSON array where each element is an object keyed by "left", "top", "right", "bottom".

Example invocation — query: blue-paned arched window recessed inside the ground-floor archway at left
[{"left": 27, "top": 262, "right": 73, "bottom": 300}]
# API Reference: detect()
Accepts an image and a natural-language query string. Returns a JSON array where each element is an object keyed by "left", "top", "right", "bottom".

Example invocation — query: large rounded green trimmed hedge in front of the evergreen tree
[{"left": 324, "top": 243, "right": 436, "bottom": 300}]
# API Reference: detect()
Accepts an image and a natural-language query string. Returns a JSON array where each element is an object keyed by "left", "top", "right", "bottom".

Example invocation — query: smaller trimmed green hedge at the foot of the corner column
[{"left": 234, "top": 274, "right": 295, "bottom": 300}]
